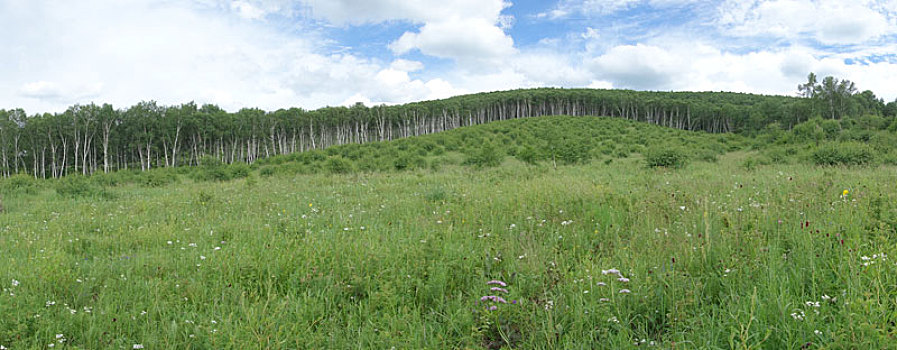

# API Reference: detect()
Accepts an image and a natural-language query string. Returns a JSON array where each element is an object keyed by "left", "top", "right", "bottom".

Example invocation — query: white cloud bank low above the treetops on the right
[{"left": 590, "top": 42, "right": 897, "bottom": 100}]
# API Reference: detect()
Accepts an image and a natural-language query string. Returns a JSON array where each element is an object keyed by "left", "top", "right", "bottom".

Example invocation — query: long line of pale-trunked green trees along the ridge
[{"left": 0, "top": 74, "right": 897, "bottom": 178}]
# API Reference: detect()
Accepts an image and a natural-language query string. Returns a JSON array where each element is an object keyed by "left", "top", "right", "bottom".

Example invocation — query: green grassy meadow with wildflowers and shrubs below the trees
[{"left": 0, "top": 117, "right": 897, "bottom": 349}]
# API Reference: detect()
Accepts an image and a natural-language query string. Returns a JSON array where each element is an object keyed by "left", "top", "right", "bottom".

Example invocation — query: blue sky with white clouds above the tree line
[{"left": 0, "top": 0, "right": 897, "bottom": 114}]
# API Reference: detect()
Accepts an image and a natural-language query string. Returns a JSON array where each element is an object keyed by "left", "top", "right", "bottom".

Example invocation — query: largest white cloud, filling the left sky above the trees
[{"left": 0, "top": 0, "right": 476, "bottom": 112}]
